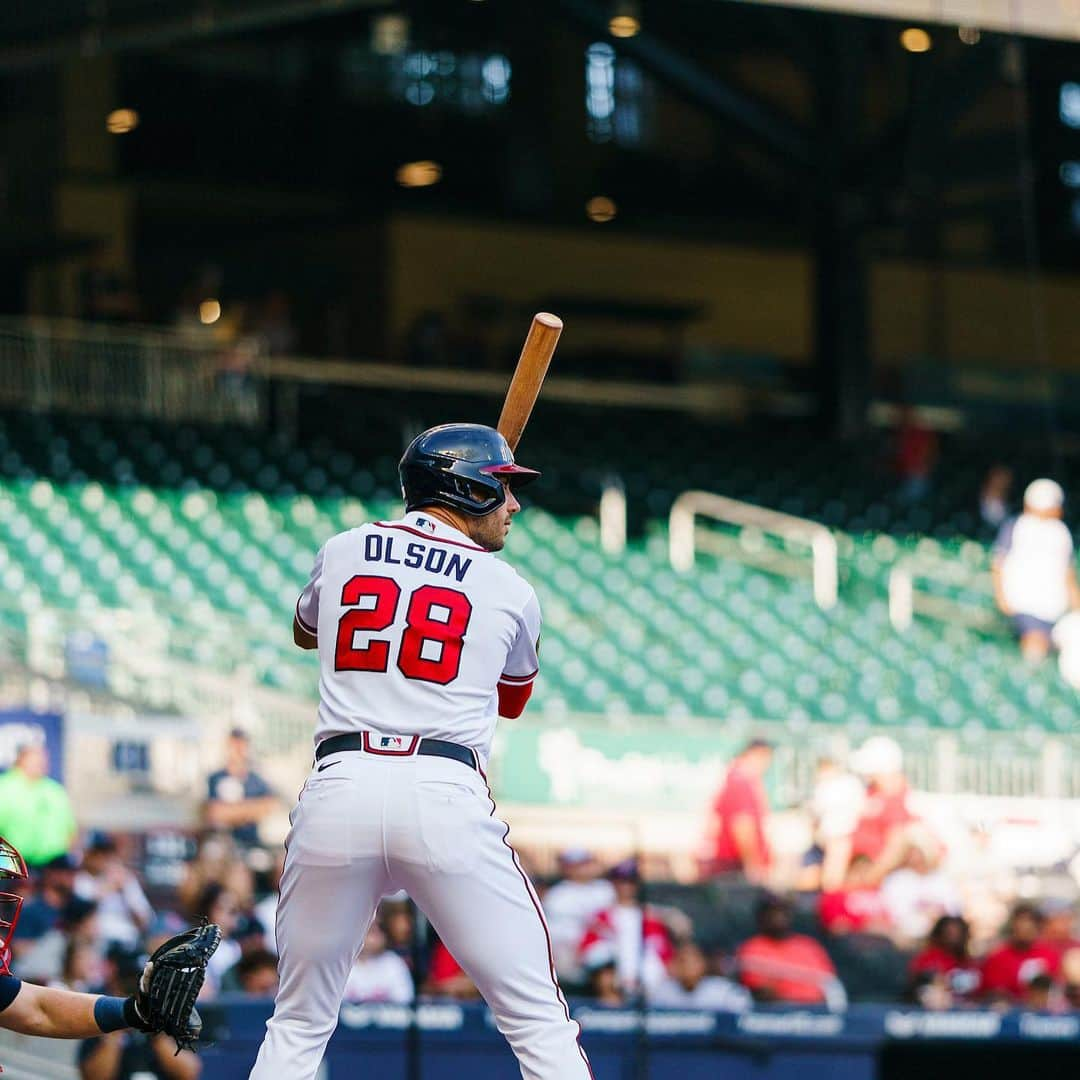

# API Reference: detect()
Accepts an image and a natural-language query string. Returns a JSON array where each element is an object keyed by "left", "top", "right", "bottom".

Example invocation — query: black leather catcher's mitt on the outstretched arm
[{"left": 130, "top": 922, "right": 221, "bottom": 1053}]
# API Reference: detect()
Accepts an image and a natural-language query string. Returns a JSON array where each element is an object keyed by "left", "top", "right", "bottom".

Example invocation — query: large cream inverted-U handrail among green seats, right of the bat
[{"left": 667, "top": 491, "right": 838, "bottom": 610}]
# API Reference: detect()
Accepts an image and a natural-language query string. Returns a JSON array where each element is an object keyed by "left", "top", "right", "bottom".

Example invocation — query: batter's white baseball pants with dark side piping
[{"left": 251, "top": 751, "right": 593, "bottom": 1080}]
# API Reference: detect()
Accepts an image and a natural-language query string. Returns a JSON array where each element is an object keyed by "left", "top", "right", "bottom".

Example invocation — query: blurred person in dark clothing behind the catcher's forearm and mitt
[{"left": 79, "top": 947, "right": 202, "bottom": 1080}]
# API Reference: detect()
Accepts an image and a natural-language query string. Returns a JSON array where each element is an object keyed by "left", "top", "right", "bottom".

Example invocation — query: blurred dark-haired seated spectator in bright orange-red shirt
[{"left": 735, "top": 895, "right": 837, "bottom": 1004}]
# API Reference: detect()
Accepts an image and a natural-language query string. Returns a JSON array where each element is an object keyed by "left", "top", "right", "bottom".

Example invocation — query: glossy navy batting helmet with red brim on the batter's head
[{"left": 397, "top": 423, "right": 540, "bottom": 517}]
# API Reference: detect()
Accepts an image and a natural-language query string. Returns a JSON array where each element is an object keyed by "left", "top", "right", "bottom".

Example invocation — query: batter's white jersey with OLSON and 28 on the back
[{"left": 296, "top": 511, "right": 540, "bottom": 764}]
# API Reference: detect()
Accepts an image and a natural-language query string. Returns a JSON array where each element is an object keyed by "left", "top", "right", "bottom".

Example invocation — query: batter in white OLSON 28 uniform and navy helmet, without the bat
[{"left": 251, "top": 423, "right": 592, "bottom": 1080}]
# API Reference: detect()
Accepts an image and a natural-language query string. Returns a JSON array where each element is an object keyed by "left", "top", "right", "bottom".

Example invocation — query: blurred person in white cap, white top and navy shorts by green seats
[{"left": 991, "top": 480, "right": 1080, "bottom": 663}]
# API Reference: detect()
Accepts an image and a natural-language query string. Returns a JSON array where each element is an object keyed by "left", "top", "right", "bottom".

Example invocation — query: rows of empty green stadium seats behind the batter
[{"left": 0, "top": 416, "right": 1075, "bottom": 731}]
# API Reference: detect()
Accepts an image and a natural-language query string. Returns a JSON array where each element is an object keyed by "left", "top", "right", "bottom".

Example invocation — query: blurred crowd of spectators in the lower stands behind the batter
[{"left": 0, "top": 730, "right": 1080, "bottom": 1067}]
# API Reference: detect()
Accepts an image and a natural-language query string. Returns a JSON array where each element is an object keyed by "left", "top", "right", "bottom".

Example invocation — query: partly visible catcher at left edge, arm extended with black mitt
[{"left": 0, "top": 837, "right": 217, "bottom": 1049}]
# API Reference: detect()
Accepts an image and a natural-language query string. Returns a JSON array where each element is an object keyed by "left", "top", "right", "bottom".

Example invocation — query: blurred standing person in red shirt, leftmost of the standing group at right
[{"left": 708, "top": 739, "right": 772, "bottom": 883}]
